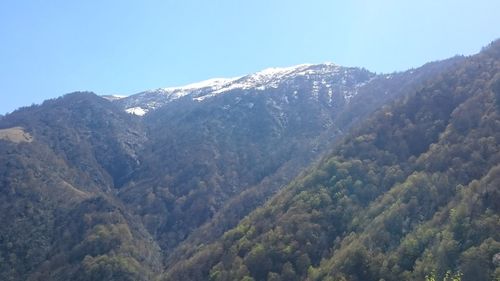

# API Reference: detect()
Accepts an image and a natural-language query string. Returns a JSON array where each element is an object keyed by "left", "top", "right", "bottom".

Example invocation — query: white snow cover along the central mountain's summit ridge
[{"left": 118, "top": 63, "right": 376, "bottom": 116}]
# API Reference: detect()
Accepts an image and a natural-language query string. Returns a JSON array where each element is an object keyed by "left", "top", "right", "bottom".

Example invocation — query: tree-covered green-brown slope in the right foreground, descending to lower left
[{"left": 164, "top": 41, "right": 500, "bottom": 280}]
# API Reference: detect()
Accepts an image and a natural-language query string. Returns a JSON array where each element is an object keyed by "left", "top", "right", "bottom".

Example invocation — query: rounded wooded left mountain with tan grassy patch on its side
[{"left": 0, "top": 93, "right": 161, "bottom": 280}]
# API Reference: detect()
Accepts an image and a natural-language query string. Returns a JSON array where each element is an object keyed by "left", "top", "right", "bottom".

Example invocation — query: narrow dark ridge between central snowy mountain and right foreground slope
[{"left": 161, "top": 57, "right": 463, "bottom": 264}]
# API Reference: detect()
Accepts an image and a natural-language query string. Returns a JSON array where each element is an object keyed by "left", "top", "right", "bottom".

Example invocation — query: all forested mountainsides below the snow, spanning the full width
[{"left": 0, "top": 40, "right": 500, "bottom": 281}]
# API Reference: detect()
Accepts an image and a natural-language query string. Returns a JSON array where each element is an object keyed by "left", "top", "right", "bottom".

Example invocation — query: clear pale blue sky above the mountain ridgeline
[{"left": 0, "top": 0, "right": 500, "bottom": 114}]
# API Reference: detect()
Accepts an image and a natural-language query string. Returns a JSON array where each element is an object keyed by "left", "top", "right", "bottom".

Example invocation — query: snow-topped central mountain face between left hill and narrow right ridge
[{"left": 116, "top": 65, "right": 373, "bottom": 254}]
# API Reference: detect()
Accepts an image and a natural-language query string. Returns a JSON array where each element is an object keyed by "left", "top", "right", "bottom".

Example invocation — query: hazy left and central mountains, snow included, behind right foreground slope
[{"left": 0, "top": 47, "right": 472, "bottom": 280}]
